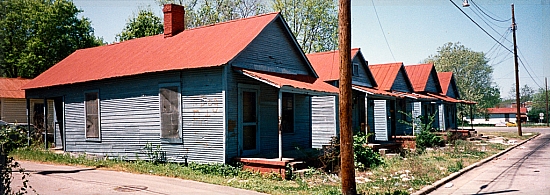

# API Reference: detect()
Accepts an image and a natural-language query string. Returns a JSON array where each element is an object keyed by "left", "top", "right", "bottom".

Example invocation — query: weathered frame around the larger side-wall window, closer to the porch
[{"left": 158, "top": 82, "right": 183, "bottom": 144}]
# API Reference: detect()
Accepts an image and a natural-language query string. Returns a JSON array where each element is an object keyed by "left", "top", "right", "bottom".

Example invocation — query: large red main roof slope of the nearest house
[{"left": 23, "top": 13, "right": 279, "bottom": 89}]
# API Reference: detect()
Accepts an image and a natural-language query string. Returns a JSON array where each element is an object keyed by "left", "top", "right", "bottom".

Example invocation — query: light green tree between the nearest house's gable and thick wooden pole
[{"left": 272, "top": 0, "right": 338, "bottom": 53}]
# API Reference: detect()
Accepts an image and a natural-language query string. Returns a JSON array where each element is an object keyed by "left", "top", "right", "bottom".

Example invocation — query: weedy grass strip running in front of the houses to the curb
[{"left": 11, "top": 132, "right": 535, "bottom": 195}]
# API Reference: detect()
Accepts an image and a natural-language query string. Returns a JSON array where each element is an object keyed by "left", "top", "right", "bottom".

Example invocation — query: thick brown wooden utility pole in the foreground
[{"left": 338, "top": 0, "right": 357, "bottom": 195}]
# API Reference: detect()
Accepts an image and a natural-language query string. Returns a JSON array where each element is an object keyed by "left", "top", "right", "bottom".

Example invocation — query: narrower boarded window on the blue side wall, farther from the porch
[{"left": 84, "top": 92, "right": 99, "bottom": 139}]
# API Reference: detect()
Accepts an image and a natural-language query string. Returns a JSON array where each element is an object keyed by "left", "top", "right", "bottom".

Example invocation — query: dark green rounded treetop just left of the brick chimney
[{"left": 116, "top": 8, "right": 164, "bottom": 41}]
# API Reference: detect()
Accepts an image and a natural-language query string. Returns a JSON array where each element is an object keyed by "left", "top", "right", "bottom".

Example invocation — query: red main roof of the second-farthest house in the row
[{"left": 405, "top": 64, "right": 439, "bottom": 92}]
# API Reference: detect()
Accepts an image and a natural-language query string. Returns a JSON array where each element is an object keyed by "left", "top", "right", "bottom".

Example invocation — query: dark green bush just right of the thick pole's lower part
[{"left": 353, "top": 132, "right": 384, "bottom": 169}]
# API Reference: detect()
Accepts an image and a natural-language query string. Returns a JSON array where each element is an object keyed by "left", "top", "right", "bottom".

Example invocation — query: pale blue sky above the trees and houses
[{"left": 73, "top": 0, "right": 550, "bottom": 98}]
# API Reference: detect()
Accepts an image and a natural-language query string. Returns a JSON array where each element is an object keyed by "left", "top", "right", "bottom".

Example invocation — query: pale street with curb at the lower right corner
[{"left": 430, "top": 127, "right": 550, "bottom": 195}]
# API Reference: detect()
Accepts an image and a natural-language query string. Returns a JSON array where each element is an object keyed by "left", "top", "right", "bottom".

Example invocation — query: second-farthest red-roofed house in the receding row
[{"left": 405, "top": 64, "right": 442, "bottom": 129}]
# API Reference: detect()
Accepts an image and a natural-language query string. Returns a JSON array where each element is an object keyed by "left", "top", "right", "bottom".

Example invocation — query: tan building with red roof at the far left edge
[{"left": 0, "top": 78, "right": 53, "bottom": 133}]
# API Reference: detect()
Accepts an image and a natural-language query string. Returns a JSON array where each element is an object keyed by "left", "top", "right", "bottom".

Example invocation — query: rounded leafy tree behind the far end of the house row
[{"left": 424, "top": 42, "right": 501, "bottom": 116}]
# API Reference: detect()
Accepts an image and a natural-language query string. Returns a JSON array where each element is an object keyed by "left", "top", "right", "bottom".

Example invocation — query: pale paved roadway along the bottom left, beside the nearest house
[{"left": 8, "top": 161, "right": 268, "bottom": 195}]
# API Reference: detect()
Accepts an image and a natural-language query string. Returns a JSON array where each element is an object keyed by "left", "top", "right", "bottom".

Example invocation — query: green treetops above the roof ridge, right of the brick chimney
[{"left": 157, "top": 0, "right": 267, "bottom": 28}]
